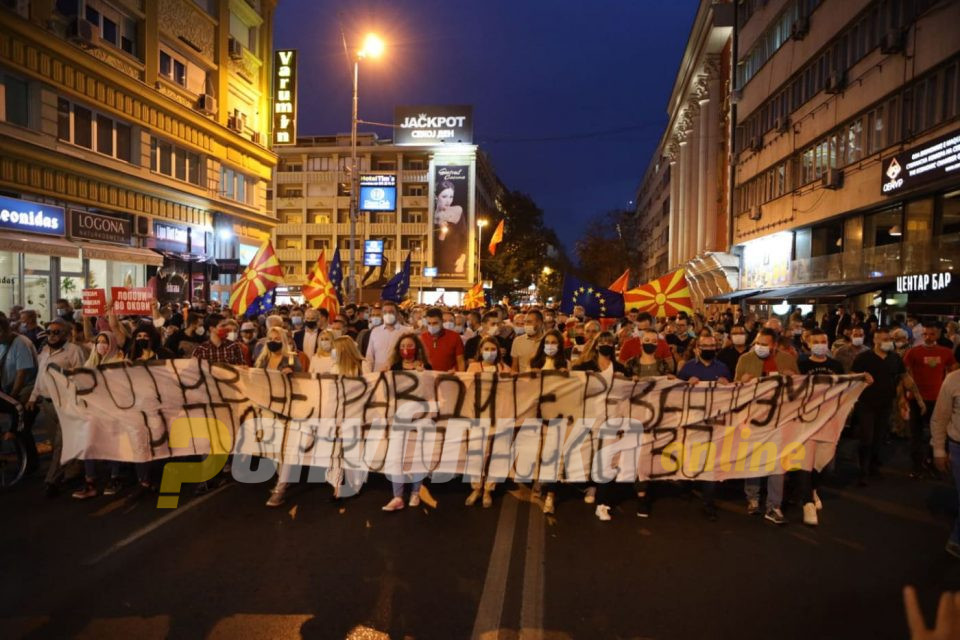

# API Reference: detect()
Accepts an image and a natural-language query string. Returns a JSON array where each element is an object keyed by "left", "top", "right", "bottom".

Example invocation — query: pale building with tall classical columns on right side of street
[{"left": 635, "top": 0, "right": 736, "bottom": 304}]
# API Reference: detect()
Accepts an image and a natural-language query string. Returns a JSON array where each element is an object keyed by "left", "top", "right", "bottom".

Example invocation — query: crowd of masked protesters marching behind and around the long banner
[{"left": 0, "top": 300, "right": 960, "bottom": 544}]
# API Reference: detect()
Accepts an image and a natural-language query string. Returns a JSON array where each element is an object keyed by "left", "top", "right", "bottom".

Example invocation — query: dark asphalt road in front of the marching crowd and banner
[{"left": 0, "top": 441, "right": 960, "bottom": 640}]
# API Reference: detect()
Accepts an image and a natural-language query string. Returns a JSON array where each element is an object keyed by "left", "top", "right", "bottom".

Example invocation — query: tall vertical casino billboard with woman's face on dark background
[{"left": 433, "top": 165, "right": 470, "bottom": 280}]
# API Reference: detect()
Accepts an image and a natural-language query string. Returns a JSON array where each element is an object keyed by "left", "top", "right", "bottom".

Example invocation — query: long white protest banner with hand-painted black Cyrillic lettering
[{"left": 50, "top": 360, "right": 866, "bottom": 482}]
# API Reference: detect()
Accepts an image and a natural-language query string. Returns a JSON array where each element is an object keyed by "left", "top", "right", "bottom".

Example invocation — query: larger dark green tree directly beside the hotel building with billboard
[{"left": 480, "top": 191, "right": 569, "bottom": 300}]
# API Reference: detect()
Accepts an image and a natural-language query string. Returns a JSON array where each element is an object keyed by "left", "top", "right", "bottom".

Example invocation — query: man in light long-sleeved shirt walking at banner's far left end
[{"left": 27, "top": 318, "right": 86, "bottom": 498}]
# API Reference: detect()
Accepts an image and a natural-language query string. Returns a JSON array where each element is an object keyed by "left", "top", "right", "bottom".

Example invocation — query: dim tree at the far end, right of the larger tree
[{"left": 574, "top": 210, "right": 639, "bottom": 287}]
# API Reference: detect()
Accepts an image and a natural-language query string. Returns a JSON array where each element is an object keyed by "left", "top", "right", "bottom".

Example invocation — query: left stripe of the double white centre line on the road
[{"left": 470, "top": 495, "right": 520, "bottom": 640}]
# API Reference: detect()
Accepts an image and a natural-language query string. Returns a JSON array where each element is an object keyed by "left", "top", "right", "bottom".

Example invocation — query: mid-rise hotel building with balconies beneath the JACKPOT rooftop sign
[{"left": 271, "top": 133, "right": 503, "bottom": 304}]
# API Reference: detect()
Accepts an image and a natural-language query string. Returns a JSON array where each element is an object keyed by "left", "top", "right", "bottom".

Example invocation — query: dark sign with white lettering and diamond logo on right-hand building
[{"left": 880, "top": 130, "right": 960, "bottom": 196}]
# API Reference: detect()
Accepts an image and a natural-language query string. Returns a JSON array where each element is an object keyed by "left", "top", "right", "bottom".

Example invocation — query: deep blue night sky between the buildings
[{"left": 274, "top": 0, "right": 698, "bottom": 255}]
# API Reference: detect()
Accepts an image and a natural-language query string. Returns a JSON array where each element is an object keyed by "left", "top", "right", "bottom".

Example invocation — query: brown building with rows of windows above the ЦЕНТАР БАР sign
[{"left": 732, "top": 0, "right": 960, "bottom": 313}]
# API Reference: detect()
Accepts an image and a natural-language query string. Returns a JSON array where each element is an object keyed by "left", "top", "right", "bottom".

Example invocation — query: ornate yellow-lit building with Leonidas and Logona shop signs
[{"left": 0, "top": 0, "right": 276, "bottom": 317}]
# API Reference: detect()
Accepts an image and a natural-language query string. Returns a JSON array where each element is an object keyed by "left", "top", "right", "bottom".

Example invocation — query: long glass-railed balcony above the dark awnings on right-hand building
[{"left": 790, "top": 233, "right": 960, "bottom": 284}]
